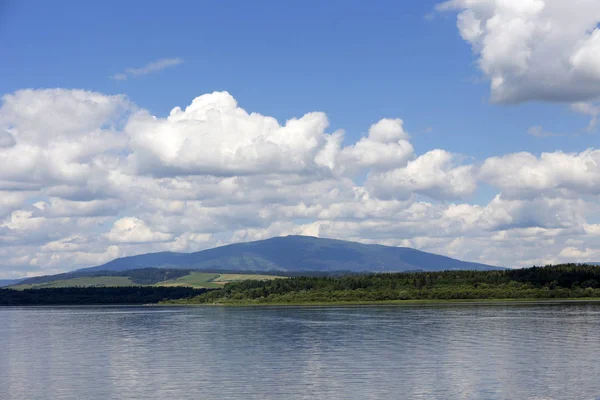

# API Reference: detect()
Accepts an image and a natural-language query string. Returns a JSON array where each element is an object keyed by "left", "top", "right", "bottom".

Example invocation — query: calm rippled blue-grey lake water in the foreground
[{"left": 0, "top": 303, "right": 600, "bottom": 400}]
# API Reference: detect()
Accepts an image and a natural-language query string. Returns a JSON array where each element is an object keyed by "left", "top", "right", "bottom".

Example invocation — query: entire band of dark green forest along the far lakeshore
[{"left": 0, "top": 264, "right": 600, "bottom": 305}]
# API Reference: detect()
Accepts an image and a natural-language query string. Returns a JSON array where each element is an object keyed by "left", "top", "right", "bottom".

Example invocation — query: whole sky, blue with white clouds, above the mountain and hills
[{"left": 0, "top": 0, "right": 600, "bottom": 278}]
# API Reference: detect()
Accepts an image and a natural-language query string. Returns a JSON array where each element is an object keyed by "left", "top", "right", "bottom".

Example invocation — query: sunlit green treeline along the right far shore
[{"left": 169, "top": 264, "right": 600, "bottom": 303}]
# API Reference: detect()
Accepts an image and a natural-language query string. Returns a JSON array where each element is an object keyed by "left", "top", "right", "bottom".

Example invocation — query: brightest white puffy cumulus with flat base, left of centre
[{"left": 125, "top": 92, "right": 340, "bottom": 176}]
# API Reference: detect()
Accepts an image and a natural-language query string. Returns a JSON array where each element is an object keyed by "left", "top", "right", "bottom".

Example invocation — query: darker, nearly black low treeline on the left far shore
[{"left": 0, "top": 286, "right": 211, "bottom": 306}]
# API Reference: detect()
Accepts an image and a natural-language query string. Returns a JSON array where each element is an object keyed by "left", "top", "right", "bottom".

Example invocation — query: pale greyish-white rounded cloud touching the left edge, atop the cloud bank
[{"left": 0, "top": 89, "right": 130, "bottom": 185}]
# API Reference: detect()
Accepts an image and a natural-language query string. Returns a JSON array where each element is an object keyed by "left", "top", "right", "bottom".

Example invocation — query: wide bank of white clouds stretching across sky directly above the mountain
[{"left": 0, "top": 89, "right": 600, "bottom": 276}]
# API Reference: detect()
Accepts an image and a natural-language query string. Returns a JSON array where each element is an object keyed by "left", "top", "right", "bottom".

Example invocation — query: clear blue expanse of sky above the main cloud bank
[{"left": 0, "top": 1, "right": 596, "bottom": 159}]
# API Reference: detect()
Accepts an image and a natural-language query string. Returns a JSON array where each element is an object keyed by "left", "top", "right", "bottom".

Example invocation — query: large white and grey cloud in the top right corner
[{"left": 437, "top": 0, "right": 600, "bottom": 103}]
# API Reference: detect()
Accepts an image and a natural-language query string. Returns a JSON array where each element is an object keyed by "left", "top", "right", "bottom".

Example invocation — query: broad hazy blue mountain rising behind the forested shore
[{"left": 80, "top": 236, "right": 503, "bottom": 272}]
